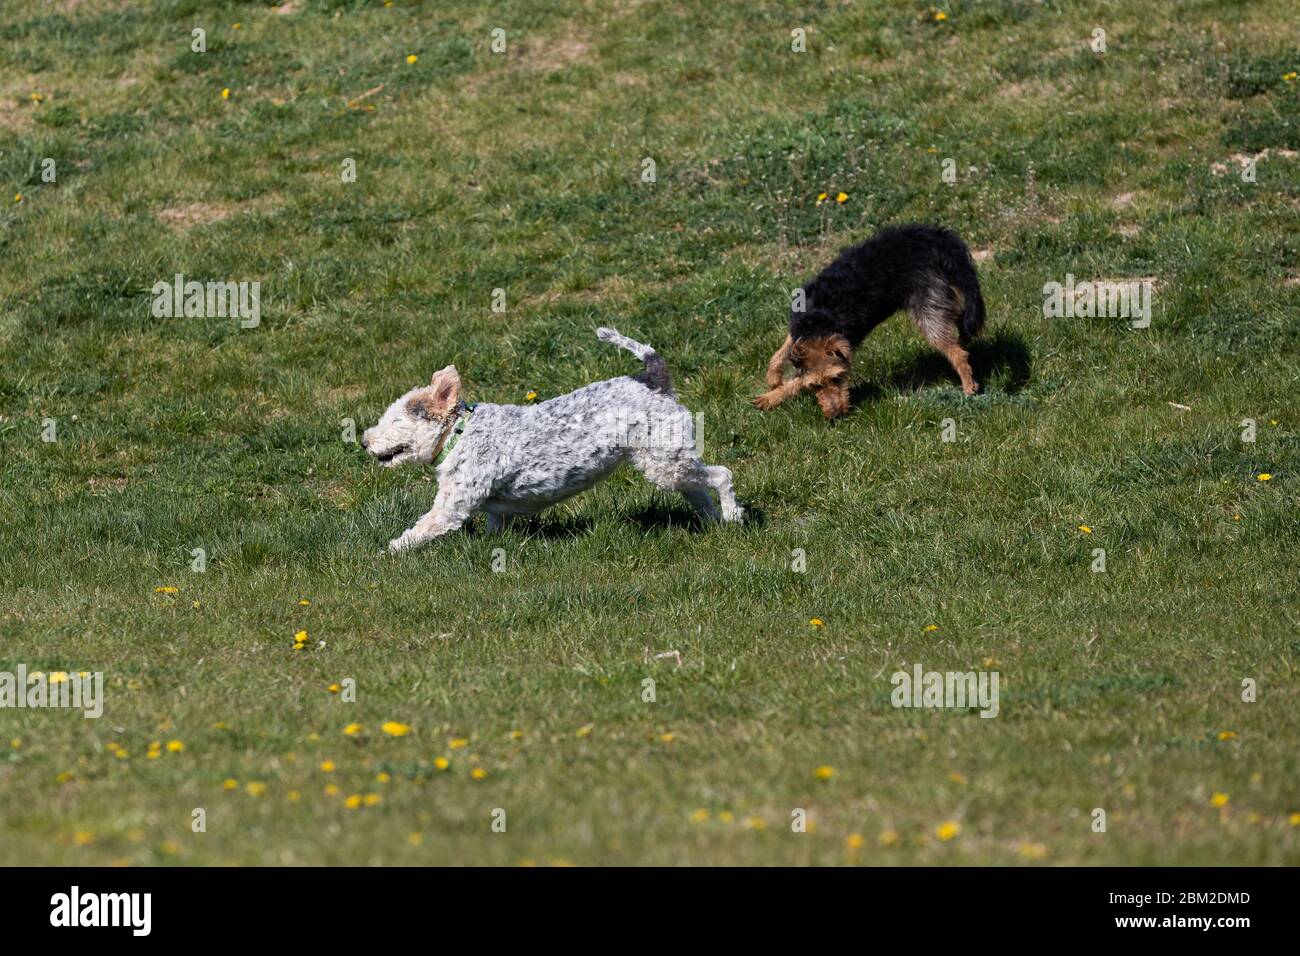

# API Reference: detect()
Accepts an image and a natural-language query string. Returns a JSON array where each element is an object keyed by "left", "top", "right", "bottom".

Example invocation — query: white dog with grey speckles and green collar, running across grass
[{"left": 361, "top": 329, "right": 745, "bottom": 551}]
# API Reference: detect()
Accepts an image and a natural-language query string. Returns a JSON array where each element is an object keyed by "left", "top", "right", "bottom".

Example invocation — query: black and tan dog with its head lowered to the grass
[{"left": 754, "top": 225, "right": 984, "bottom": 419}]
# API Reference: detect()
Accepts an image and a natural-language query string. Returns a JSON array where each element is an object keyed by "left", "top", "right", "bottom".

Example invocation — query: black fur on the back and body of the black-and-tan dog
[{"left": 790, "top": 225, "right": 984, "bottom": 347}]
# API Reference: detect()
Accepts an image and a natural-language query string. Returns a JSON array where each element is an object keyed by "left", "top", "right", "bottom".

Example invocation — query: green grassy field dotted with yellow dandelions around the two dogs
[{"left": 0, "top": 0, "right": 1300, "bottom": 865}]
